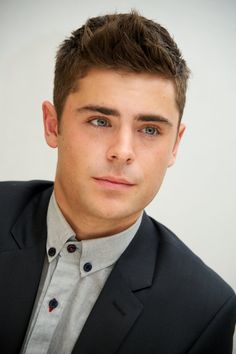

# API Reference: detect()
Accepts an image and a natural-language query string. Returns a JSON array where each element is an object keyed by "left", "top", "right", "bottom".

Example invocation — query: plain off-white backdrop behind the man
[{"left": 0, "top": 0, "right": 236, "bottom": 348}]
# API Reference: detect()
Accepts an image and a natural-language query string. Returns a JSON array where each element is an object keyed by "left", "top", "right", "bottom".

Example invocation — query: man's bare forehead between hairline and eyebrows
[{"left": 65, "top": 68, "right": 179, "bottom": 123}]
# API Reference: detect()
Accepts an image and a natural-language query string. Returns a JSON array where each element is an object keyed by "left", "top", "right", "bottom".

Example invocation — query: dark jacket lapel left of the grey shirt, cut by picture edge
[{"left": 0, "top": 188, "right": 52, "bottom": 353}]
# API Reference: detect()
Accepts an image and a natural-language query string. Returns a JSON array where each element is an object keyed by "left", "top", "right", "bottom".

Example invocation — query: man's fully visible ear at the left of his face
[{"left": 42, "top": 101, "right": 58, "bottom": 148}]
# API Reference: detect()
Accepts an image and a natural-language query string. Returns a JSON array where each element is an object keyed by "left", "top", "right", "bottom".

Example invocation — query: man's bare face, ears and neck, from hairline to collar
[{"left": 43, "top": 68, "right": 185, "bottom": 239}]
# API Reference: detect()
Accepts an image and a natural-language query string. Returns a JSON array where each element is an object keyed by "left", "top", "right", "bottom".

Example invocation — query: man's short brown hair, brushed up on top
[{"left": 53, "top": 11, "right": 190, "bottom": 119}]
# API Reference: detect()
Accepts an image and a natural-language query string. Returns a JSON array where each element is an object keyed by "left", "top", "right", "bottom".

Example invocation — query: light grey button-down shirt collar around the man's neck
[{"left": 47, "top": 193, "right": 142, "bottom": 276}]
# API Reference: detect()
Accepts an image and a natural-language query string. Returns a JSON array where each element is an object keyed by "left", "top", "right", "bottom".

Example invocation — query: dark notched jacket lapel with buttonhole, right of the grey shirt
[{"left": 73, "top": 214, "right": 158, "bottom": 354}]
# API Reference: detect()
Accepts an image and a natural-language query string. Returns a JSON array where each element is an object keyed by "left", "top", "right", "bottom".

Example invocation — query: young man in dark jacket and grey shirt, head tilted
[{"left": 0, "top": 12, "right": 236, "bottom": 354}]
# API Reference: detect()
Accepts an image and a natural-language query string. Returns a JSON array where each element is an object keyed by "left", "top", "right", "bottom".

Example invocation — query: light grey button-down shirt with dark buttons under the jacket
[{"left": 21, "top": 193, "right": 142, "bottom": 354}]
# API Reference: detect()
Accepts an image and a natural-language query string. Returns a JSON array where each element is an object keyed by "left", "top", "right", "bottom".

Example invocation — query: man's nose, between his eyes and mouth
[{"left": 107, "top": 129, "right": 135, "bottom": 164}]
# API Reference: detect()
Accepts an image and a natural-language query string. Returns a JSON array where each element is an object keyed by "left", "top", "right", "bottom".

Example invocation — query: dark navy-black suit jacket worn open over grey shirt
[{"left": 0, "top": 181, "right": 236, "bottom": 354}]
